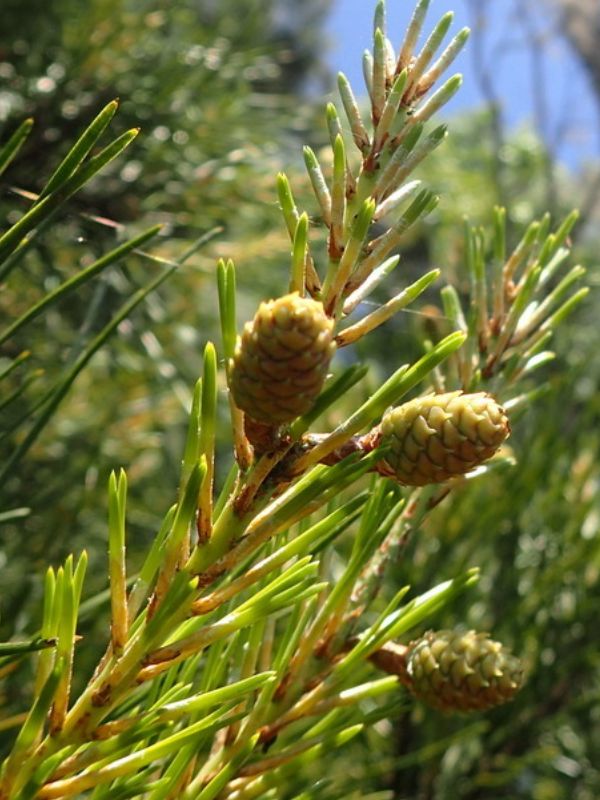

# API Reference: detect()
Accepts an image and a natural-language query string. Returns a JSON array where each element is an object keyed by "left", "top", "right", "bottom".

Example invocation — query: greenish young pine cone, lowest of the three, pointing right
[{"left": 406, "top": 631, "right": 523, "bottom": 711}]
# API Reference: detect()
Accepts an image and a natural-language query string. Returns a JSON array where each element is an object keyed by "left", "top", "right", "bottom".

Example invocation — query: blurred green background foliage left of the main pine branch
[{"left": 0, "top": 0, "right": 326, "bottom": 624}]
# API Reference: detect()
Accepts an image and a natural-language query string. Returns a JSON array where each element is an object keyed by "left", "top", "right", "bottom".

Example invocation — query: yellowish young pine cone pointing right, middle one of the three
[{"left": 378, "top": 392, "right": 510, "bottom": 486}]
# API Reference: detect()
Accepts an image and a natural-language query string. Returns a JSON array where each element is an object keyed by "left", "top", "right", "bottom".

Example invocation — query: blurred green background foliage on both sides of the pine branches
[{"left": 0, "top": 0, "right": 600, "bottom": 800}]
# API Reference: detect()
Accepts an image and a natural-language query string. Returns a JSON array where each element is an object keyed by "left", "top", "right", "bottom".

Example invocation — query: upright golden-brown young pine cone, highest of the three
[{"left": 231, "top": 292, "right": 335, "bottom": 425}]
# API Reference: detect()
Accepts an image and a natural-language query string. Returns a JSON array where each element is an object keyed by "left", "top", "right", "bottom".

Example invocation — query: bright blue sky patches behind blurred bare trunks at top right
[{"left": 327, "top": 0, "right": 600, "bottom": 169}]
